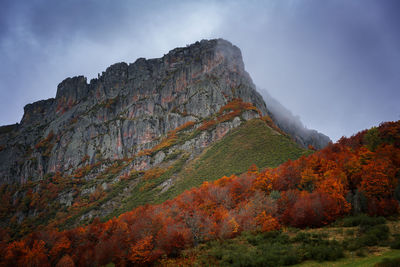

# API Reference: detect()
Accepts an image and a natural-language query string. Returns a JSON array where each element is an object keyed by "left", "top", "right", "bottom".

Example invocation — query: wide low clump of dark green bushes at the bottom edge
[{"left": 202, "top": 231, "right": 344, "bottom": 266}]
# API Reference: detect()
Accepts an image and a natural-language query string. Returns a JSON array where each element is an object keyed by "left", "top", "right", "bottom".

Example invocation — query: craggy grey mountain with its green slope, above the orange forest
[{"left": 0, "top": 39, "right": 326, "bottom": 237}]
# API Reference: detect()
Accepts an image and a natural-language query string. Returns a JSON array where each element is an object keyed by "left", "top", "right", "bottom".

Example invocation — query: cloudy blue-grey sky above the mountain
[{"left": 0, "top": 0, "right": 400, "bottom": 140}]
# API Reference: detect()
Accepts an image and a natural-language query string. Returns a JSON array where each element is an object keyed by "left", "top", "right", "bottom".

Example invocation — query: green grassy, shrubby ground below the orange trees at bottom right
[{"left": 160, "top": 215, "right": 400, "bottom": 267}]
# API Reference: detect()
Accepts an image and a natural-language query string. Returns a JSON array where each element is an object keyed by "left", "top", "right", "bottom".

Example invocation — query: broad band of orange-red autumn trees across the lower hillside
[{"left": 0, "top": 122, "right": 400, "bottom": 266}]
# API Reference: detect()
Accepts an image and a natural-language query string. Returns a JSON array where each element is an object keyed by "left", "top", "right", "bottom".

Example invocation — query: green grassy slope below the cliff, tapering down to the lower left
[{"left": 103, "top": 119, "right": 310, "bottom": 220}]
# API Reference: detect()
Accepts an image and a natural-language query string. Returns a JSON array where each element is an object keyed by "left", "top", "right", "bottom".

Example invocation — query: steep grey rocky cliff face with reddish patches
[{"left": 0, "top": 39, "right": 267, "bottom": 186}]
